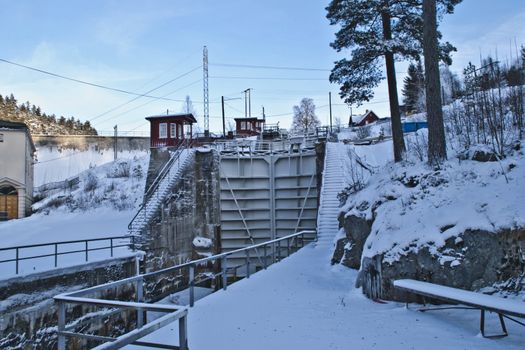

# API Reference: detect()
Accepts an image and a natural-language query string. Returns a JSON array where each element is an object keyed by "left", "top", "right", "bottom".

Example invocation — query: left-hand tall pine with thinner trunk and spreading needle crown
[{"left": 326, "top": 0, "right": 461, "bottom": 161}]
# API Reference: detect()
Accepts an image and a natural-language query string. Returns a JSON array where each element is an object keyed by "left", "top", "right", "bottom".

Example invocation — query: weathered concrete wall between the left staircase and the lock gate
[{"left": 140, "top": 150, "right": 220, "bottom": 296}]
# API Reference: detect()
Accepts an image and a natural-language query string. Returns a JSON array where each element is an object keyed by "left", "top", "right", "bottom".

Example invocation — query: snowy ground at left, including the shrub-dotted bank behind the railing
[{"left": 0, "top": 156, "right": 148, "bottom": 278}]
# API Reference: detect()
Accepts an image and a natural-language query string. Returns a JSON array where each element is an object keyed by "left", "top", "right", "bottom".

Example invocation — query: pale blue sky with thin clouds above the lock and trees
[{"left": 0, "top": 0, "right": 525, "bottom": 133}]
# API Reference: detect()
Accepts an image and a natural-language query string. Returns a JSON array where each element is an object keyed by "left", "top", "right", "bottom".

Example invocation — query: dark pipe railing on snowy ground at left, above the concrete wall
[{"left": 0, "top": 236, "right": 135, "bottom": 275}]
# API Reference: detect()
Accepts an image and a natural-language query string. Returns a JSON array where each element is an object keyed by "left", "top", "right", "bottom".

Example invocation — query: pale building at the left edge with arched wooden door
[{"left": 0, "top": 120, "right": 36, "bottom": 220}]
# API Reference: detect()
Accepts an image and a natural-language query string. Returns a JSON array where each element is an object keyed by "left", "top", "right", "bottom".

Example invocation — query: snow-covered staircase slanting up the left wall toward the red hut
[{"left": 128, "top": 142, "right": 195, "bottom": 235}]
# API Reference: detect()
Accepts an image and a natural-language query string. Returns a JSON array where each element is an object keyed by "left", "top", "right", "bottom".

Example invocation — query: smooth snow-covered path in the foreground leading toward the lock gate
[{"left": 126, "top": 245, "right": 525, "bottom": 350}]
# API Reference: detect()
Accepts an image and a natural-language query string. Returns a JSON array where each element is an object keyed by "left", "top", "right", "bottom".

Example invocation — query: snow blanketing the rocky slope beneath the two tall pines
[{"left": 341, "top": 131, "right": 525, "bottom": 266}]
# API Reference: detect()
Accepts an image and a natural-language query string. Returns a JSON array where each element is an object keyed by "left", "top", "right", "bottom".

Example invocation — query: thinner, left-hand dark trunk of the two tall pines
[{"left": 381, "top": 11, "right": 405, "bottom": 162}]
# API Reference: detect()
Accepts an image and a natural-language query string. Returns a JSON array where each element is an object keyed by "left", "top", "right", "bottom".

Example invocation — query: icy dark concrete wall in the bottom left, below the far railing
[{"left": 0, "top": 257, "right": 136, "bottom": 349}]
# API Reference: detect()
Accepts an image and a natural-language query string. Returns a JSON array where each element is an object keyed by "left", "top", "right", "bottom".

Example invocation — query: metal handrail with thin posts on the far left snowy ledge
[{"left": 0, "top": 235, "right": 134, "bottom": 275}]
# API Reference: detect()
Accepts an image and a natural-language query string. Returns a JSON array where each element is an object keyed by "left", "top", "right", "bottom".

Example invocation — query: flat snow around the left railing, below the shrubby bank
[{"left": 0, "top": 209, "right": 135, "bottom": 279}]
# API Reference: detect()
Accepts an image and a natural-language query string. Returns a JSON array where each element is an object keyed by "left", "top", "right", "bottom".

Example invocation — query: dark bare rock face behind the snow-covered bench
[{"left": 357, "top": 230, "right": 525, "bottom": 302}]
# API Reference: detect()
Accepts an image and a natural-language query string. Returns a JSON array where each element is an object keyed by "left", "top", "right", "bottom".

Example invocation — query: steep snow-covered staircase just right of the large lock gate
[{"left": 317, "top": 142, "right": 345, "bottom": 247}]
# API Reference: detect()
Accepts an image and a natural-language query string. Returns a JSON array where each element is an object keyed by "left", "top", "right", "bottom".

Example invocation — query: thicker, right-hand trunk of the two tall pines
[{"left": 423, "top": 0, "right": 447, "bottom": 165}]
